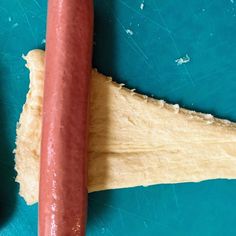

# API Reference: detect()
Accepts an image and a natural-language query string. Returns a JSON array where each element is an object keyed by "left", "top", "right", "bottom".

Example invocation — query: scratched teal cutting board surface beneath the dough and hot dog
[{"left": 0, "top": 0, "right": 236, "bottom": 236}]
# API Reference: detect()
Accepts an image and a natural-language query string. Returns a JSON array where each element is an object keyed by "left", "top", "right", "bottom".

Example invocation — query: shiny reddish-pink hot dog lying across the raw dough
[{"left": 39, "top": 0, "right": 93, "bottom": 236}]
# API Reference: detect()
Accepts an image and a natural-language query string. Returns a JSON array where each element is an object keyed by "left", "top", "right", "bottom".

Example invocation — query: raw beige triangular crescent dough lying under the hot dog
[{"left": 15, "top": 50, "right": 236, "bottom": 204}]
